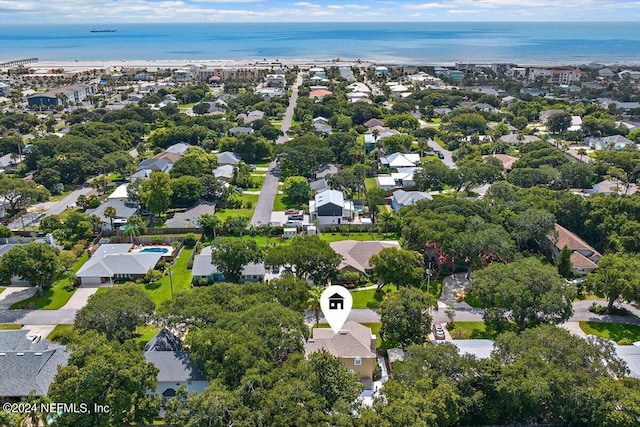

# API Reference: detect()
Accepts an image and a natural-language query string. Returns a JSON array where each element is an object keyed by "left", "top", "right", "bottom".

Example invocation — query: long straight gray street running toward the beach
[{"left": 251, "top": 73, "right": 302, "bottom": 226}]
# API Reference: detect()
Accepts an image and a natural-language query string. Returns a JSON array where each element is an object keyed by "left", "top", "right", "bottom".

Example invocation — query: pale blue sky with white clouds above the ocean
[{"left": 0, "top": 0, "right": 640, "bottom": 26}]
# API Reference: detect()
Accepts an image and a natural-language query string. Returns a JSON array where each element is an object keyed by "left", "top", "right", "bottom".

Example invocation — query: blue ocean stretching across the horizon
[{"left": 0, "top": 22, "right": 640, "bottom": 65}]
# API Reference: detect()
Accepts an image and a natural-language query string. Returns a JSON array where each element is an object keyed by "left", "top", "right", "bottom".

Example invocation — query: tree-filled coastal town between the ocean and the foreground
[{"left": 0, "top": 58, "right": 640, "bottom": 426}]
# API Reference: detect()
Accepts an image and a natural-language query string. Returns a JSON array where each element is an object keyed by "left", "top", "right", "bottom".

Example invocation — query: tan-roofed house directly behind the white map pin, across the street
[{"left": 329, "top": 240, "right": 400, "bottom": 274}]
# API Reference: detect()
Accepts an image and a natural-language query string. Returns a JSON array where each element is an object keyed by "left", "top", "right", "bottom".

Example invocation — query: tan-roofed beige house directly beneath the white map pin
[{"left": 304, "top": 321, "right": 377, "bottom": 390}]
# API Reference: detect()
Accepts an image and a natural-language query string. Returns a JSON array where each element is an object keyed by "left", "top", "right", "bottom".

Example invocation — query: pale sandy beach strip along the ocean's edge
[{"left": 6, "top": 58, "right": 640, "bottom": 71}]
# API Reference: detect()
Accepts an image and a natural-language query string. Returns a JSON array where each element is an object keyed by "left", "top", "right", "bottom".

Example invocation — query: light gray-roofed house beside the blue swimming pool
[{"left": 76, "top": 243, "right": 164, "bottom": 285}]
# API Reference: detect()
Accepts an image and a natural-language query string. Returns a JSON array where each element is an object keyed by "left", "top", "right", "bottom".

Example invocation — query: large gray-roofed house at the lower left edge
[{"left": 0, "top": 329, "right": 69, "bottom": 396}]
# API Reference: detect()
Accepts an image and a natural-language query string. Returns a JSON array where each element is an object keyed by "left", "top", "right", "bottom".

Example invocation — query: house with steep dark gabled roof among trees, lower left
[{"left": 144, "top": 328, "right": 209, "bottom": 403}]
